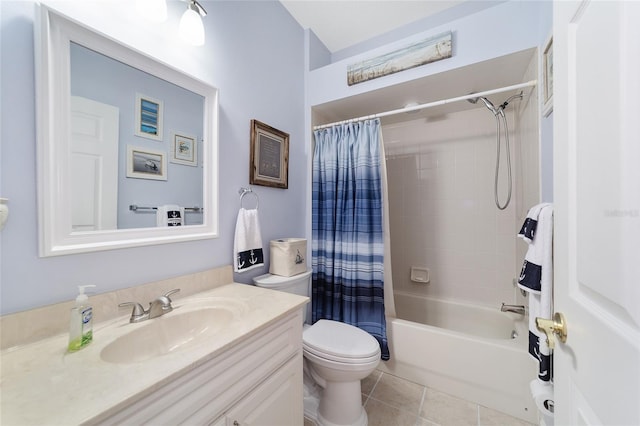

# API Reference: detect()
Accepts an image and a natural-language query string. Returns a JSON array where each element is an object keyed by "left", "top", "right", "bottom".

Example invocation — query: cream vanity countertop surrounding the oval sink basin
[{"left": 0, "top": 283, "right": 308, "bottom": 425}]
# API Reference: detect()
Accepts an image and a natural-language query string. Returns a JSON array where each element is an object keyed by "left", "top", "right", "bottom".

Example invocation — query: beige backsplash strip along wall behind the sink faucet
[{"left": 0, "top": 266, "right": 233, "bottom": 350}]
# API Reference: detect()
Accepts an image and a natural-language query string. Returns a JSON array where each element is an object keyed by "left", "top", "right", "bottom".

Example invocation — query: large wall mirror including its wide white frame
[{"left": 34, "top": 5, "right": 218, "bottom": 256}]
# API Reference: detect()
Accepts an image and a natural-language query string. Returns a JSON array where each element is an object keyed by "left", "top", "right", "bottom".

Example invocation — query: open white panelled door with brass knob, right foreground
[{"left": 553, "top": 1, "right": 640, "bottom": 425}]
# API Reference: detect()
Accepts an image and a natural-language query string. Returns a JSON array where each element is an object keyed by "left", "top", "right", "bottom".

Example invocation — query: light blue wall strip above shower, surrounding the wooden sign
[{"left": 307, "top": 1, "right": 551, "bottom": 107}]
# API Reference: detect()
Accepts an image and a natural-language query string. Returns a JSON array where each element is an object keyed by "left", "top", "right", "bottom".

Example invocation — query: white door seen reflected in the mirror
[{"left": 71, "top": 96, "right": 119, "bottom": 231}]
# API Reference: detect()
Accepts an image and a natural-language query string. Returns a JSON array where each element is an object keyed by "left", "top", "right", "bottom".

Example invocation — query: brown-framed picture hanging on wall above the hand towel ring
[{"left": 249, "top": 120, "right": 289, "bottom": 189}]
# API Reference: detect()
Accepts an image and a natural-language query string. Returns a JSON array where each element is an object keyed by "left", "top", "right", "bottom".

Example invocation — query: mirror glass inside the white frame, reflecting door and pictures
[{"left": 69, "top": 42, "right": 205, "bottom": 232}]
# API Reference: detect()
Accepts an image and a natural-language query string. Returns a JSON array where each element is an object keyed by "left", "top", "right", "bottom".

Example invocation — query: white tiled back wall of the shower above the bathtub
[{"left": 383, "top": 109, "right": 521, "bottom": 309}]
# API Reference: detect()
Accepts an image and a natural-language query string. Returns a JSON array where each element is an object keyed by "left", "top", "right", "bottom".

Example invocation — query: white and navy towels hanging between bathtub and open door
[{"left": 518, "top": 203, "right": 553, "bottom": 382}]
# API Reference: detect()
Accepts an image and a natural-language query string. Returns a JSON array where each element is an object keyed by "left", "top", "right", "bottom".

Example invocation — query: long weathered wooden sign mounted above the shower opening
[{"left": 347, "top": 31, "right": 452, "bottom": 86}]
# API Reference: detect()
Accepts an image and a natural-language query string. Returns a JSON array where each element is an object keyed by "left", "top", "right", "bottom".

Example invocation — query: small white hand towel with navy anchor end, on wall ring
[{"left": 233, "top": 208, "right": 264, "bottom": 272}]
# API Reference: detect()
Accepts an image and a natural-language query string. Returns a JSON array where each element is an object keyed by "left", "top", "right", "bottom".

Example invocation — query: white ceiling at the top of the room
[{"left": 280, "top": 0, "right": 464, "bottom": 53}]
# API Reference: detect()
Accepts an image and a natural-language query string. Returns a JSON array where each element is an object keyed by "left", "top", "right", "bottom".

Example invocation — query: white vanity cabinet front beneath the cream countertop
[{"left": 94, "top": 310, "right": 304, "bottom": 426}]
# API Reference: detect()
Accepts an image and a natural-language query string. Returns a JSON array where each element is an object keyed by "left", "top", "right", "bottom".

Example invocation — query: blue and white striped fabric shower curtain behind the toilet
[{"left": 311, "top": 119, "right": 389, "bottom": 360}]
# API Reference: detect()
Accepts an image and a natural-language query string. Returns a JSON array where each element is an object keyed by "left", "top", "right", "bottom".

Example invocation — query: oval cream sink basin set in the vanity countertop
[{"left": 100, "top": 298, "right": 245, "bottom": 364}]
